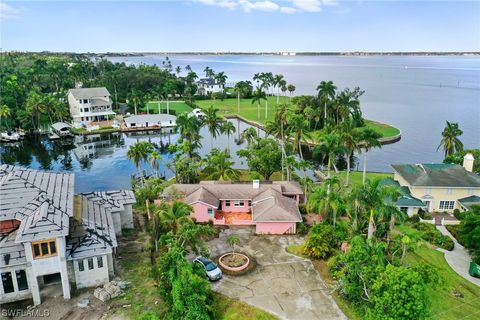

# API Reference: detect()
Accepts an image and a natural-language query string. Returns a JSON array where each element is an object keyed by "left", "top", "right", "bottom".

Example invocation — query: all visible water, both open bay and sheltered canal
[{"left": 0, "top": 56, "right": 480, "bottom": 192}]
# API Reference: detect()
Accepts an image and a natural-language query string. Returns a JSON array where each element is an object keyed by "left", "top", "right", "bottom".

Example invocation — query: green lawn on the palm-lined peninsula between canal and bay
[{"left": 195, "top": 96, "right": 400, "bottom": 138}]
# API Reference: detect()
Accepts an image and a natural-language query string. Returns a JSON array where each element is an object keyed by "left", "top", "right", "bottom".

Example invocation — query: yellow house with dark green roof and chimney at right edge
[{"left": 392, "top": 153, "right": 480, "bottom": 212}]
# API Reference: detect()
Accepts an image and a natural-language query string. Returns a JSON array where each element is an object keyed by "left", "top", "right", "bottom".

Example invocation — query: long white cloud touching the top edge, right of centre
[{"left": 193, "top": 0, "right": 338, "bottom": 14}]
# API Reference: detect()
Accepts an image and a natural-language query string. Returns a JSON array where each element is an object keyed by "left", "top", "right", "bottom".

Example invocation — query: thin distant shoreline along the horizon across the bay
[{"left": 1, "top": 51, "right": 480, "bottom": 57}]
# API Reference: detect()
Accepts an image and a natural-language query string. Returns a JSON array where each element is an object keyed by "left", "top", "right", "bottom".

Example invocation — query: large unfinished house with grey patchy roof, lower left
[{"left": 0, "top": 165, "right": 135, "bottom": 305}]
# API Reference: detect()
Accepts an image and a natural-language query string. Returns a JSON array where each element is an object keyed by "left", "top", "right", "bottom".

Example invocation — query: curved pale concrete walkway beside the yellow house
[{"left": 437, "top": 226, "right": 480, "bottom": 286}]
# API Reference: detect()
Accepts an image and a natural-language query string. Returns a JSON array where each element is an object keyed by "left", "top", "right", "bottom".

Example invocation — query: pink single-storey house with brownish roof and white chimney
[{"left": 163, "top": 180, "right": 303, "bottom": 234}]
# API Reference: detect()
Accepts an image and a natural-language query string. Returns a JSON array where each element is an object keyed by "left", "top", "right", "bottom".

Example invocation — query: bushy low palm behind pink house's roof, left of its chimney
[{"left": 203, "top": 148, "right": 240, "bottom": 181}]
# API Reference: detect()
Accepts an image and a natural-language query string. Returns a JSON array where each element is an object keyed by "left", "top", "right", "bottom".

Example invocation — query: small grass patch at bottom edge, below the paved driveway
[{"left": 213, "top": 293, "right": 277, "bottom": 320}]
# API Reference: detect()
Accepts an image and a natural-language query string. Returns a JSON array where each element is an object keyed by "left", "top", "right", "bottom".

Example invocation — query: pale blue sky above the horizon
[{"left": 0, "top": 0, "right": 480, "bottom": 52}]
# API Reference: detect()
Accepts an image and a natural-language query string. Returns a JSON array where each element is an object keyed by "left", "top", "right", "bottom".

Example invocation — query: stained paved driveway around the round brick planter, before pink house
[{"left": 209, "top": 230, "right": 347, "bottom": 320}]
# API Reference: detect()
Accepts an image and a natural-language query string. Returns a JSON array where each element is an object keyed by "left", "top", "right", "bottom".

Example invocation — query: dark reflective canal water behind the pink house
[{"left": 0, "top": 120, "right": 265, "bottom": 193}]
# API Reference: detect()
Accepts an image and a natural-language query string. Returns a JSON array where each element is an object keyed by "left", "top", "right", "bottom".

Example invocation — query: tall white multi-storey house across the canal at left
[{"left": 67, "top": 87, "right": 115, "bottom": 128}]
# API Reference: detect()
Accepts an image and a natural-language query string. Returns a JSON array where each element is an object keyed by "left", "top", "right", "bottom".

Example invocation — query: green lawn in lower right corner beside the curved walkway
[{"left": 406, "top": 246, "right": 480, "bottom": 320}]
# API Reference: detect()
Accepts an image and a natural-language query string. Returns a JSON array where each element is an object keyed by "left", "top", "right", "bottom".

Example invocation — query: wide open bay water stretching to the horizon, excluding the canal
[{"left": 111, "top": 55, "right": 480, "bottom": 172}]
